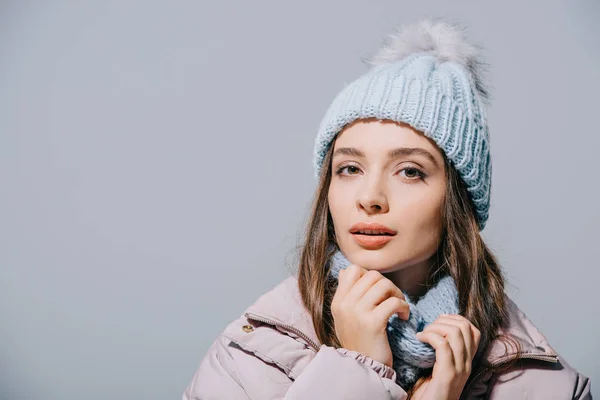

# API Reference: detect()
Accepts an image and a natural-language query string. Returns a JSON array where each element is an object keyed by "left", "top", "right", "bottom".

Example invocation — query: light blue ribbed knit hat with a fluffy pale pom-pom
[{"left": 314, "top": 20, "right": 492, "bottom": 230}]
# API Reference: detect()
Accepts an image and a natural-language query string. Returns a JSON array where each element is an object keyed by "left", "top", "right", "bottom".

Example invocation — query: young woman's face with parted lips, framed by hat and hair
[{"left": 329, "top": 120, "right": 446, "bottom": 273}]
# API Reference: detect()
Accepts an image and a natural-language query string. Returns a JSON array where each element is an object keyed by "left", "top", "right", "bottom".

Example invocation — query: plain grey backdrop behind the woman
[{"left": 0, "top": 0, "right": 600, "bottom": 400}]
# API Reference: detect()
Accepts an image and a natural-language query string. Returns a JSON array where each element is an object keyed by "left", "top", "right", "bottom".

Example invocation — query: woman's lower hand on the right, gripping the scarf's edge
[{"left": 413, "top": 314, "right": 481, "bottom": 400}]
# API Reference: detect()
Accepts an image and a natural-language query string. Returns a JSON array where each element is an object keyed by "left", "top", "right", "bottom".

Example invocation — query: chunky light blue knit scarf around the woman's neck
[{"left": 331, "top": 250, "right": 459, "bottom": 390}]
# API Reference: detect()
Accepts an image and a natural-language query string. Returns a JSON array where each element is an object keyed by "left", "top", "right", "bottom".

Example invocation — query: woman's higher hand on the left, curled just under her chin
[{"left": 331, "top": 265, "right": 410, "bottom": 367}]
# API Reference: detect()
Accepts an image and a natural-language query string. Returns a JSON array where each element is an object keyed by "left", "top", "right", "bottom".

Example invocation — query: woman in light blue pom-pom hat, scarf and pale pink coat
[{"left": 183, "top": 21, "right": 591, "bottom": 400}]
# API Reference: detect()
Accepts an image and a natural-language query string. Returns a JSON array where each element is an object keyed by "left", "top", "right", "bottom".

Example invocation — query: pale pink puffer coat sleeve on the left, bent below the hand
[{"left": 183, "top": 337, "right": 406, "bottom": 400}]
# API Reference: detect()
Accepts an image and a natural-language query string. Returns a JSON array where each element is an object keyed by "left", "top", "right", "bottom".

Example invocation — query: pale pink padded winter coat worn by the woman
[{"left": 183, "top": 277, "right": 592, "bottom": 400}]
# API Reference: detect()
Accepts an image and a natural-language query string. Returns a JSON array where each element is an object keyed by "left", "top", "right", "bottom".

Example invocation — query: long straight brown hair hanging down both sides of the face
[{"left": 298, "top": 128, "right": 507, "bottom": 394}]
